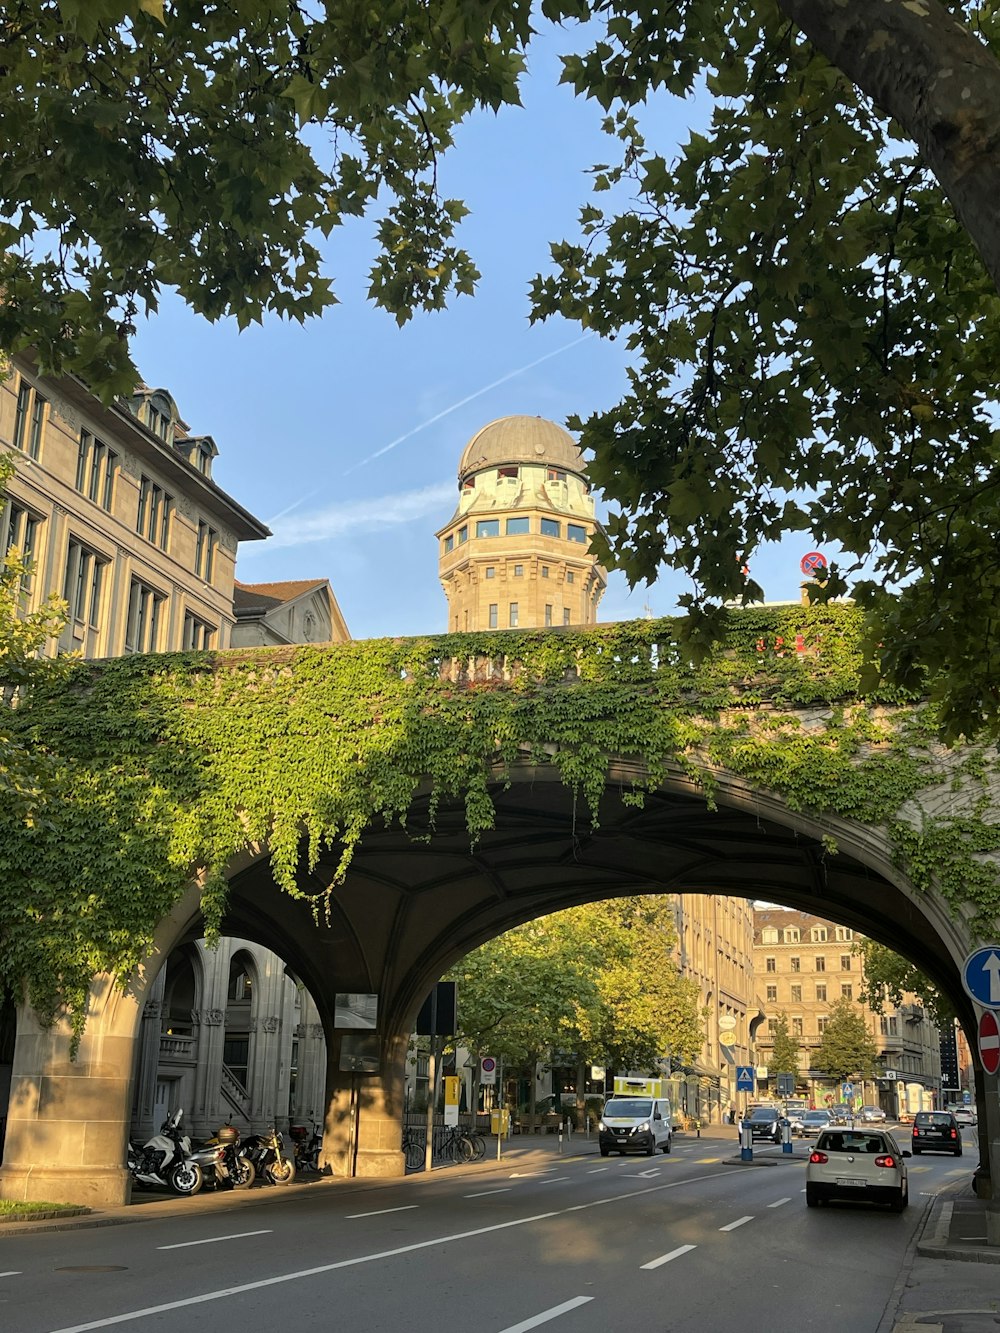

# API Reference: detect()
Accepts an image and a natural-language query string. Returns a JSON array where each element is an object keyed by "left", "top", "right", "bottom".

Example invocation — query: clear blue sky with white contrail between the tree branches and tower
[{"left": 133, "top": 22, "right": 809, "bottom": 639}]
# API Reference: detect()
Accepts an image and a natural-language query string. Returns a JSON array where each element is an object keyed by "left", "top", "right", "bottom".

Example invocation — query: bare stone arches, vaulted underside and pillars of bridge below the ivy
[{"left": 3, "top": 757, "right": 997, "bottom": 1201}]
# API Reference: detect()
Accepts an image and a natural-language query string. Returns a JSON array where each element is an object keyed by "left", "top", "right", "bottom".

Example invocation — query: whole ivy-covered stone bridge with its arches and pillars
[{"left": 0, "top": 607, "right": 1000, "bottom": 1242}]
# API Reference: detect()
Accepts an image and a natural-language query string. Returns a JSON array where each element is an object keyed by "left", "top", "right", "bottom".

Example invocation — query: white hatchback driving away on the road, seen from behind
[{"left": 805, "top": 1126, "right": 911, "bottom": 1213}]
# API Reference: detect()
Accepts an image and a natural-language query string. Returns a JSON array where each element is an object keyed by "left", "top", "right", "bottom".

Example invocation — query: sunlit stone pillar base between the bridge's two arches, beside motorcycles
[{"left": 323, "top": 1032, "right": 407, "bottom": 1177}]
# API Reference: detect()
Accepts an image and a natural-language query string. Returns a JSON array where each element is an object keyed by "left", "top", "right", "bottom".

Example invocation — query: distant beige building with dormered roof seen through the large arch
[{"left": 753, "top": 908, "right": 941, "bottom": 1117}]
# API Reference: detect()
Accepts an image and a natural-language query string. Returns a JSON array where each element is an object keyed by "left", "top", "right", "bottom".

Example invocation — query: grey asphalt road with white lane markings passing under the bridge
[{"left": 0, "top": 1132, "right": 975, "bottom": 1333}]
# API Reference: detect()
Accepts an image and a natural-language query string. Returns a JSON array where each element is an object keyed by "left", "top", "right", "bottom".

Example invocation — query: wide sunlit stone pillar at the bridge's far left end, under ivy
[{"left": 0, "top": 976, "right": 141, "bottom": 1206}]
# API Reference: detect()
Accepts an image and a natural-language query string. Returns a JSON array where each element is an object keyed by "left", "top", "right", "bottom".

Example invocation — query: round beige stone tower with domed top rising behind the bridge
[{"left": 437, "top": 416, "right": 608, "bottom": 631}]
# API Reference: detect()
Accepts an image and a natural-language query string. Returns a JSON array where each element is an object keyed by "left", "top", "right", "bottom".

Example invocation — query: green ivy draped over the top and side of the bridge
[{"left": 0, "top": 607, "right": 1000, "bottom": 1034}]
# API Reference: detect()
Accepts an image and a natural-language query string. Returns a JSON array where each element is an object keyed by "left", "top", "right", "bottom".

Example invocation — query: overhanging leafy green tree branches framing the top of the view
[{"left": 0, "top": 0, "right": 1000, "bottom": 736}]
